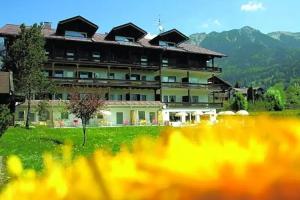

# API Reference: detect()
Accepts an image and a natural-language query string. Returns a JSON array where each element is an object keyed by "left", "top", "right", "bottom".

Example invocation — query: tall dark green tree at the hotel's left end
[{"left": 4, "top": 24, "right": 50, "bottom": 128}]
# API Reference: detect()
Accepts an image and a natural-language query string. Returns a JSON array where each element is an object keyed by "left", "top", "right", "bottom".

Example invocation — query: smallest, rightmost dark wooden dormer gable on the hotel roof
[{"left": 149, "top": 29, "right": 189, "bottom": 45}]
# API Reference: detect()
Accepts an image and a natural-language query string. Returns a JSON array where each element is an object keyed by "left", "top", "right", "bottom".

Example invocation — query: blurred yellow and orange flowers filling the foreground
[{"left": 0, "top": 118, "right": 300, "bottom": 200}]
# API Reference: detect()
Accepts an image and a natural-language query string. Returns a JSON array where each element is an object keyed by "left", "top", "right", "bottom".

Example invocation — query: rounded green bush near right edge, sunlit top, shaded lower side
[{"left": 265, "top": 88, "right": 284, "bottom": 111}]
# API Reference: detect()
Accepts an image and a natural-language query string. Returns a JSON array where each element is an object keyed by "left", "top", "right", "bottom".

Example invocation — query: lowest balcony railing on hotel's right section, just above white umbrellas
[{"left": 163, "top": 102, "right": 223, "bottom": 108}]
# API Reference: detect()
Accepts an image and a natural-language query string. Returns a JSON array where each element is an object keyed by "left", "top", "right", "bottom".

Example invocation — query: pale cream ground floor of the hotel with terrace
[{"left": 15, "top": 100, "right": 216, "bottom": 127}]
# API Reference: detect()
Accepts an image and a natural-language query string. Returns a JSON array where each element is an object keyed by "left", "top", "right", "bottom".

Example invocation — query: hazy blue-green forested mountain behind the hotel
[{"left": 189, "top": 26, "right": 300, "bottom": 86}]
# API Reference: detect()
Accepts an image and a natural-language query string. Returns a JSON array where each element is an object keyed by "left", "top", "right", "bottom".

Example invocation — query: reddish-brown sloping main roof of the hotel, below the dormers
[{"left": 0, "top": 24, "right": 225, "bottom": 57}]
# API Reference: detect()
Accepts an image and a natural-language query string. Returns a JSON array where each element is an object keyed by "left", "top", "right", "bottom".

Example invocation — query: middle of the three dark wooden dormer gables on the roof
[{"left": 105, "top": 22, "right": 147, "bottom": 41}]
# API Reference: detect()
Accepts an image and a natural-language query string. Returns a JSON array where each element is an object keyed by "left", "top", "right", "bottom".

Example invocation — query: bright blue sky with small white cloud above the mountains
[{"left": 0, "top": 0, "right": 300, "bottom": 35}]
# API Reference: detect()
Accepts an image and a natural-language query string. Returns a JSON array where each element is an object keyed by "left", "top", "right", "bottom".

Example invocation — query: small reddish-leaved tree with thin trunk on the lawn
[{"left": 67, "top": 92, "right": 105, "bottom": 146}]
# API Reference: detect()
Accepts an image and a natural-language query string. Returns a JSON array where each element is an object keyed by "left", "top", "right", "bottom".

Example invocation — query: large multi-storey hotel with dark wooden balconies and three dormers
[{"left": 0, "top": 16, "right": 225, "bottom": 126}]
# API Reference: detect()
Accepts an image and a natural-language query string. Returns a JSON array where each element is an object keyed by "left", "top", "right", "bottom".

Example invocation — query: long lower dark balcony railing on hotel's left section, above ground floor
[{"left": 50, "top": 77, "right": 160, "bottom": 88}]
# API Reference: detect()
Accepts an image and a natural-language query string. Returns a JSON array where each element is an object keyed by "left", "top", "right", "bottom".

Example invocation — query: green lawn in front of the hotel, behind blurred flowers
[{"left": 0, "top": 126, "right": 162, "bottom": 170}]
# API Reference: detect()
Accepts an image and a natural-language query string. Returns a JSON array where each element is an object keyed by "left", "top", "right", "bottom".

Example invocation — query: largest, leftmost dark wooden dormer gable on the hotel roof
[{"left": 56, "top": 16, "right": 98, "bottom": 38}]
